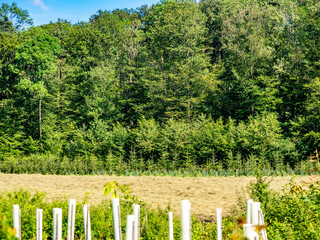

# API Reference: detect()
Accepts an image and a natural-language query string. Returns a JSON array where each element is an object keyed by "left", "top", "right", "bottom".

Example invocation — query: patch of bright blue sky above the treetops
[{"left": 0, "top": 0, "right": 159, "bottom": 26}]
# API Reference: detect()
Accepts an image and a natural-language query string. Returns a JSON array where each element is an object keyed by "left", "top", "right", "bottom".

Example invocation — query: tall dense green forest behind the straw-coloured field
[{"left": 0, "top": 0, "right": 320, "bottom": 174}]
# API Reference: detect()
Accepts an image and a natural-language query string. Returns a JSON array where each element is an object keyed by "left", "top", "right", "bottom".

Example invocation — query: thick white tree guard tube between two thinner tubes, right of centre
[{"left": 181, "top": 200, "right": 191, "bottom": 240}]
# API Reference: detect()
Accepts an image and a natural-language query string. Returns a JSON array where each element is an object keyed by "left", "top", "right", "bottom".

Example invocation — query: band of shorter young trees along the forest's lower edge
[{"left": 0, "top": 114, "right": 304, "bottom": 176}]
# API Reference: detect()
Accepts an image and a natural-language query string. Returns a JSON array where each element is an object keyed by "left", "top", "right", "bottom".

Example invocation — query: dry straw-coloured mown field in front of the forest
[{"left": 0, "top": 174, "right": 307, "bottom": 220}]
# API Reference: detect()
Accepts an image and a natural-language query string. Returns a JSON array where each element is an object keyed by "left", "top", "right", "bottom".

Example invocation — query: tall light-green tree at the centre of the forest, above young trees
[{"left": 143, "top": 1, "right": 210, "bottom": 120}]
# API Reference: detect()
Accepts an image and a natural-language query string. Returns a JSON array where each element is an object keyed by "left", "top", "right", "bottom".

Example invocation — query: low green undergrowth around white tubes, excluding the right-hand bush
[{"left": 0, "top": 190, "right": 240, "bottom": 239}]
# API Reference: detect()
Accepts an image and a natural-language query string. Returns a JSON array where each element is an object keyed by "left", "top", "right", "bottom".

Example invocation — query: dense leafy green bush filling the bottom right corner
[{"left": 250, "top": 174, "right": 320, "bottom": 239}]
